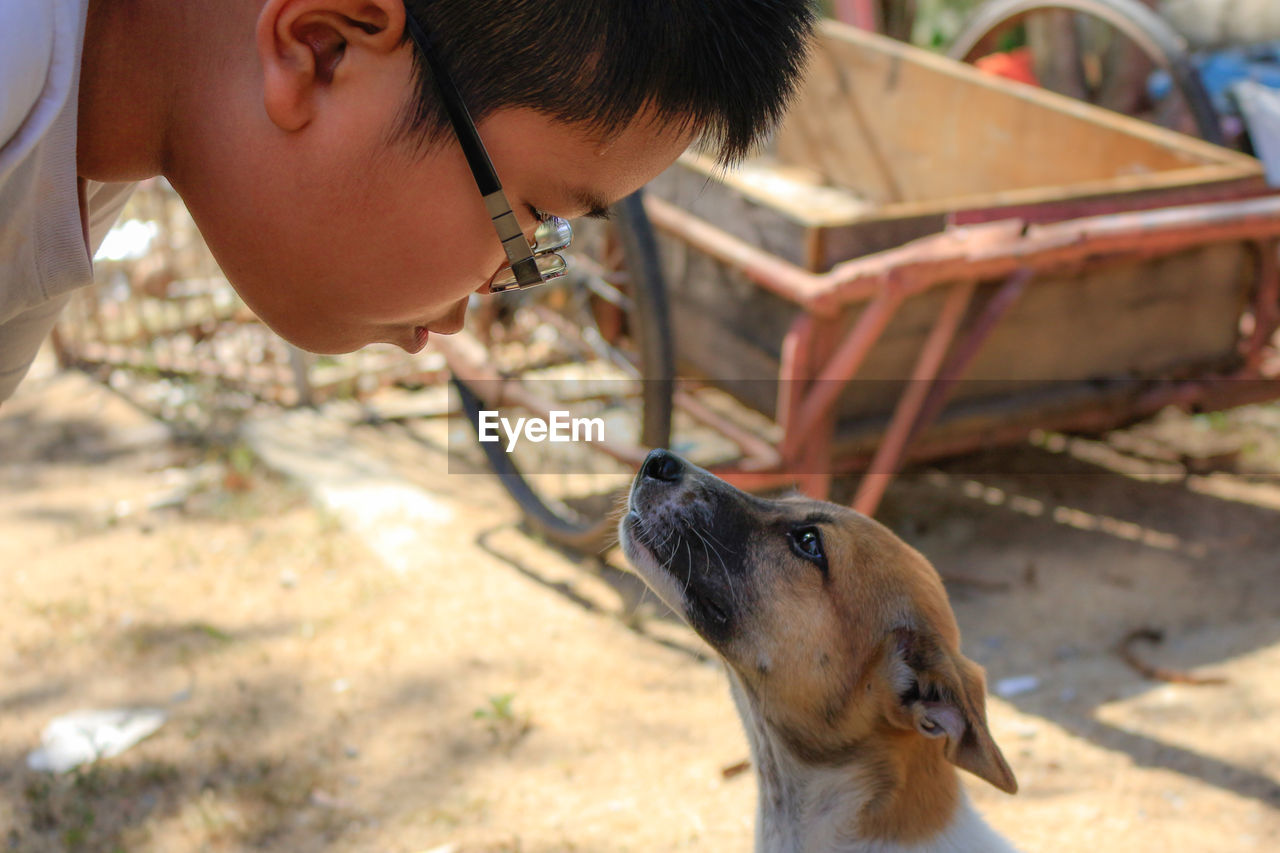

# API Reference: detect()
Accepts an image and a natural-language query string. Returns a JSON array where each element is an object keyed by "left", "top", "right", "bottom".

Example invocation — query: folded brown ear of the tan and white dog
[{"left": 890, "top": 628, "right": 1018, "bottom": 794}]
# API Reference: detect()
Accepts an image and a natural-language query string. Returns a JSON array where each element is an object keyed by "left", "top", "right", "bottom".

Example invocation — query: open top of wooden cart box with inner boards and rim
[{"left": 650, "top": 22, "right": 1266, "bottom": 272}]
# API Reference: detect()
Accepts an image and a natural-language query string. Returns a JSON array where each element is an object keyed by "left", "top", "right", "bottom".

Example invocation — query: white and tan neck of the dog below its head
[{"left": 730, "top": 670, "right": 1014, "bottom": 853}]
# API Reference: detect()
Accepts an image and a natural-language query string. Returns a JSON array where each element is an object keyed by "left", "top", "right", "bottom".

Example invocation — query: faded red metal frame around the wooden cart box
[{"left": 646, "top": 196, "right": 1280, "bottom": 514}]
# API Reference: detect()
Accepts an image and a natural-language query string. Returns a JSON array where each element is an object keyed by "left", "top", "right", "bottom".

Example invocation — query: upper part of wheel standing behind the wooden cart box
[{"left": 947, "top": 0, "right": 1222, "bottom": 145}]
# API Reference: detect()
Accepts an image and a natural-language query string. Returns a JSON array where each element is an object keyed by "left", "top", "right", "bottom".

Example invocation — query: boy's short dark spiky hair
[{"left": 398, "top": 0, "right": 815, "bottom": 163}]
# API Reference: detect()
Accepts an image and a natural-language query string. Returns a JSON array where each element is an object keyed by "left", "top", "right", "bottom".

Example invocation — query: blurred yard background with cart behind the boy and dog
[{"left": 0, "top": 0, "right": 1280, "bottom": 853}]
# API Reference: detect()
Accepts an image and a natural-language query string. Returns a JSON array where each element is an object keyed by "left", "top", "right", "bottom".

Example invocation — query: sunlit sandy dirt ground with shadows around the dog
[{"left": 0, "top": 356, "right": 1280, "bottom": 853}]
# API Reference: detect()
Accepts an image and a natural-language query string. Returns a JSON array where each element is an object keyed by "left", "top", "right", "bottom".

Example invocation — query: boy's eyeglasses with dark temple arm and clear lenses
[{"left": 404, "top": 8, "right": 573, "bottom": 293}]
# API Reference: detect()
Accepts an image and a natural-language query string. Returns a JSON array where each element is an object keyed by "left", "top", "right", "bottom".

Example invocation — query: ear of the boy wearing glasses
[{"left": 255, "top": 0, "right": 404, "bottom": 131}]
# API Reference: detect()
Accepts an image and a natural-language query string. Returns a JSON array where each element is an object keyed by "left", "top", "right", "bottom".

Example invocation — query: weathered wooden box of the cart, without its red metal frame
[{"left": 650, "top": 23, "right": 1265, "bottom": 424}]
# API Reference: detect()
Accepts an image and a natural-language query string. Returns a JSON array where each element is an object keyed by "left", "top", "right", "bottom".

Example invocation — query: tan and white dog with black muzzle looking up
[{"left": 618, "top": 451, "right": 1018, "bottom": 853}]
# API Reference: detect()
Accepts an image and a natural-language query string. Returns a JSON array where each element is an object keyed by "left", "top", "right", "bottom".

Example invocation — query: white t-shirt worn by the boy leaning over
[{"left": 0, "top": 0, "right": 134, "bottom": 401}]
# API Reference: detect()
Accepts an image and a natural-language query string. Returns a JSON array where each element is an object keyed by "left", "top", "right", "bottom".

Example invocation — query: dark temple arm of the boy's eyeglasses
[{"left": 404, "top": 10, "right": 543, "bottom": 284}]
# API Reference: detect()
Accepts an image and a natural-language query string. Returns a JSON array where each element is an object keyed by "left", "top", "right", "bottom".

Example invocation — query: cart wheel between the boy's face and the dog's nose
[{"left": 453, "top": 193, "right": 675, "bottom": 552}]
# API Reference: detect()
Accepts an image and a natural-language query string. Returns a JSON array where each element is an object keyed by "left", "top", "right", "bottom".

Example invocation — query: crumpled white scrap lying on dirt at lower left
[{"left": 27, "top": 708, "right": 168, "bottom": 774}]
